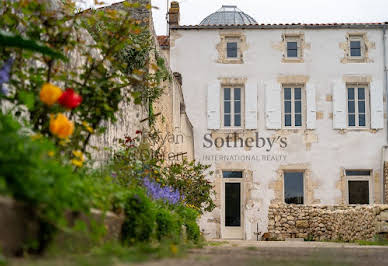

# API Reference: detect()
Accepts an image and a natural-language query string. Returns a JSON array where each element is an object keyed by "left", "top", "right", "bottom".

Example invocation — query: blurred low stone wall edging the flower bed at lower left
[{"left": 0, "top": 196, "right": 124, "bottom": 256}]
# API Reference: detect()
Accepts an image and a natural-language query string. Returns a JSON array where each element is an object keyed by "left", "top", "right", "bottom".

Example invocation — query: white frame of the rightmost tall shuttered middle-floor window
[{"left": 346, "top": 83, "right": 371, "bottom": 129}]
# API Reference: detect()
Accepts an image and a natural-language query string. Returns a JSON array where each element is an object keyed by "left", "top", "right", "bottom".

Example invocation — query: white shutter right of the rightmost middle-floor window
[{"left": 370, "top": 81, "right": 384, "bottom": 129}]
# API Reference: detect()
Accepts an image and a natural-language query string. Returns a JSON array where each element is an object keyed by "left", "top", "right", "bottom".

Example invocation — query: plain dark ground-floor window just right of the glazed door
[{"left": 284, "top": 172, "right": 304, "bottom": 204}]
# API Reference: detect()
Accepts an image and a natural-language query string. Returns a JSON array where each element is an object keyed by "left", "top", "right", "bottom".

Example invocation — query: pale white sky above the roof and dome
[{"left": 78, "top": 0, "right": 388, "bottom": 35}]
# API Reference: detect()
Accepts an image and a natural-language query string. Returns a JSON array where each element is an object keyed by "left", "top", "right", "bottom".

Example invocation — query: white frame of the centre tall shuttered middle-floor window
[{"left": 281, "top": 83, "right": 306, "bottom": 129}]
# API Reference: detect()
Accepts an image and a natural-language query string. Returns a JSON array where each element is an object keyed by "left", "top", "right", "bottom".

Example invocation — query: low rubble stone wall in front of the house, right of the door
[{"left": 268, "top": 204, "right": 388, "bottom": 241}]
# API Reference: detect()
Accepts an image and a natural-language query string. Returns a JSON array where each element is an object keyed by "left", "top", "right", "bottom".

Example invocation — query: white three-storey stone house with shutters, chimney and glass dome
[{"left": 166, "top": 2, "right": 388, "bottom": 239}]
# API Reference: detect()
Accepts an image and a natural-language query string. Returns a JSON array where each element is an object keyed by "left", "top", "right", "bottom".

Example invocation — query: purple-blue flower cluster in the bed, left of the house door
[{"left": 144, "top": 177, "right": 183, "bottom": 204}]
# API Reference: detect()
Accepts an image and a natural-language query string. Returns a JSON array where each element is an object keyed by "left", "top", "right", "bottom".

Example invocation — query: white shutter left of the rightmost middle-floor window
[{"left": 333, "top": 80, "right": 347, "bottom": 129}]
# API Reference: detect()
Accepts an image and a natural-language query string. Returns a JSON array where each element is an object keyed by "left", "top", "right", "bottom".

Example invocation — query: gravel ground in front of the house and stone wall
[{"left": 135, "top": 241, "right": 388, "bottom": 266}]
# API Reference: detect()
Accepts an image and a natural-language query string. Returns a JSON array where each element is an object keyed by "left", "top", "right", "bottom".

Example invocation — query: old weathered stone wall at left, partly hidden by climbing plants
[{"left": 85, "top": 0, "right": 194, "bottom": 164}]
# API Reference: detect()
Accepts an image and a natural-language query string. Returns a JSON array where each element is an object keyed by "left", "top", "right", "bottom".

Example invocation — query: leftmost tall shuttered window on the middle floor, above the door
[{"left": 222, "top": 87, "right": 243, "bottom": 127}]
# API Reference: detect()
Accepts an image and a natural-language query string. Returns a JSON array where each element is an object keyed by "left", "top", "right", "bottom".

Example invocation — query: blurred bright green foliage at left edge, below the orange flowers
[{"left": 0, "top": 114, "right": 88, "bottom": 222}]
